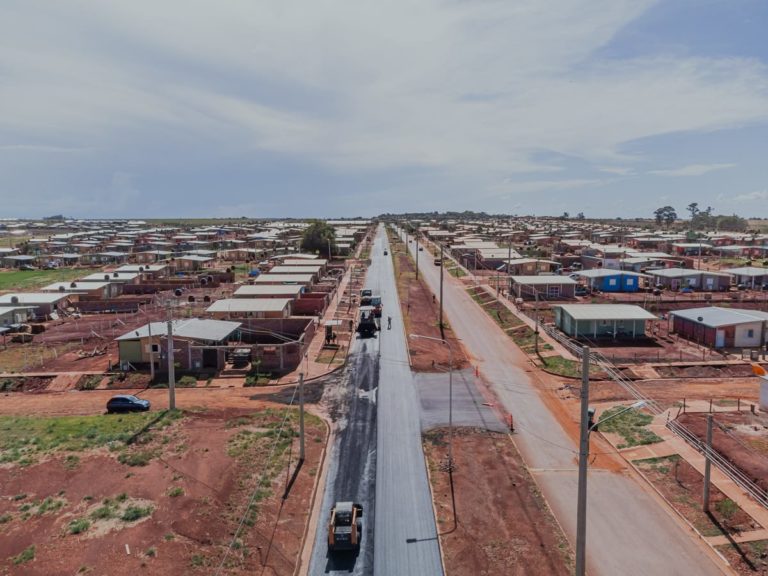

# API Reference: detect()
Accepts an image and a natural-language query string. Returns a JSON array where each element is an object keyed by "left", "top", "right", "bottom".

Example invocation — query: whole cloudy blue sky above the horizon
[{"left": 0, "top": 0, "right": 768, "bottom": 218}]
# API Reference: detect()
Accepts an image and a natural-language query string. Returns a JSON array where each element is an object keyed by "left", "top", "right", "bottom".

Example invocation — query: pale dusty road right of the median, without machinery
[{"left": 402, "top": 227, "right": 725, "bottom": 576}]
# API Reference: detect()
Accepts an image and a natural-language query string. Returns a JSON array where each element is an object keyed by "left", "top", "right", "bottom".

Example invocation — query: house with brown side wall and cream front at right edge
[{"left": 669, "top": 306, "right": 768, "bottom": 348}]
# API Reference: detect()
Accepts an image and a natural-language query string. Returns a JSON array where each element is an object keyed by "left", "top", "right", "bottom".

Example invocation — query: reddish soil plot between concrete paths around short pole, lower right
[{"left": 634, "top": 454, "right": 760, "bottom": 536}]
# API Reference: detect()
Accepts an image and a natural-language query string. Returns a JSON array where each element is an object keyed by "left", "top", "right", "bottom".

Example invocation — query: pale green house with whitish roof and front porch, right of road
[{"left": 552, "top": 304, "right": 657, "bottom": 340}]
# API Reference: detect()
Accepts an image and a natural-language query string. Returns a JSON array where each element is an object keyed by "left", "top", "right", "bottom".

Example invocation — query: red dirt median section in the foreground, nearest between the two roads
[{"left": 424, "top": 428, "right": 573, "bottom": 576}]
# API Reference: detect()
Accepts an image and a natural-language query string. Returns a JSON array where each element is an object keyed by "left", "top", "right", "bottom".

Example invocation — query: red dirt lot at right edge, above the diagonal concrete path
[{"left": 677, "top": 412, "right": 768, "bottom": 490}]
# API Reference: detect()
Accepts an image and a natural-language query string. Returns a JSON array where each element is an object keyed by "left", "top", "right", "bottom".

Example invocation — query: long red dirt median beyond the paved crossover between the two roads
[{"left": 390, "top": 236, "right": 469, "bottom": 372}]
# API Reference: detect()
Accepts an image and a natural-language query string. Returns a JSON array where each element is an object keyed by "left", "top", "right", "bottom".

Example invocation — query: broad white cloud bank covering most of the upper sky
[{"left": 0, "top": 0, "right": 768, "bottom": 216}]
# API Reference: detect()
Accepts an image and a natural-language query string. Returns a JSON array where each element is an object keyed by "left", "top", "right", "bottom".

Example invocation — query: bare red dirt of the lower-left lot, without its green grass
[{"left": 0, "top": 403, "right": 326, "bottom": 576}]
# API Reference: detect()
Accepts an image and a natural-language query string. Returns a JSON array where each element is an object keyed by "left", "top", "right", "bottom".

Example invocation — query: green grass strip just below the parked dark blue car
[{"left": 0, "top": 412, "right": 157, "bottom": 463}]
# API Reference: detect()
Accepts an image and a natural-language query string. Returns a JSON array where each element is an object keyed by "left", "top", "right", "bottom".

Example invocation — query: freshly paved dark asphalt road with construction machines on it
[{"left": 309, "top": 227, "right": 443, "bottom": 576}]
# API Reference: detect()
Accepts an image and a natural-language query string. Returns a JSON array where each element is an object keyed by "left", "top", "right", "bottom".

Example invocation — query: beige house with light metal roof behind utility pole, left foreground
[{"left": 116, "top": 318, "right": 241, "bottom": 371}]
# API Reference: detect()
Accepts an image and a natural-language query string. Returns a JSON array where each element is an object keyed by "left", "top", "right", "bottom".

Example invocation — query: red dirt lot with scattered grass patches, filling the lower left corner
[{"left": 0, "top": 403, "right": 326, "bottom": 576}]
